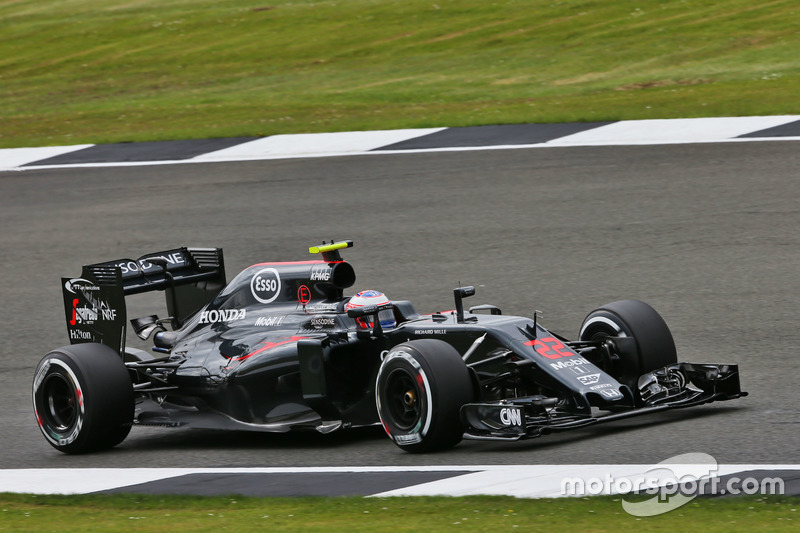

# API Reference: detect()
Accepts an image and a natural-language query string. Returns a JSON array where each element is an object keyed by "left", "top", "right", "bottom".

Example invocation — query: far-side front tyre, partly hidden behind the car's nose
[{"left": 580, "top": 300, "right": 678, "bottom": 391}]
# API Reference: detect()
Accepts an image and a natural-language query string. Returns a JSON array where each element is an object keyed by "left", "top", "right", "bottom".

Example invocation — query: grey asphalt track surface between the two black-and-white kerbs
[{"left": 0, "top": 141, "right": 800, "bottom": 474}]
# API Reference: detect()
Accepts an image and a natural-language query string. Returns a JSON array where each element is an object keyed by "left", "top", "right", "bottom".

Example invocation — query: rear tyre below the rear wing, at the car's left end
[{"left": 33, "top": 343, "right": 134, "bottom": 453}]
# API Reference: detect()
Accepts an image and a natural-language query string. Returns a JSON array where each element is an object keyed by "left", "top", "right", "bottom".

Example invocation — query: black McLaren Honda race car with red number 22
[{"left": 33, "top": 241, "right": 747, "bottom": 453}]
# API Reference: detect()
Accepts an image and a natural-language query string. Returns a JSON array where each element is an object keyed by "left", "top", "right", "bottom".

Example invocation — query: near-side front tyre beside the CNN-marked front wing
[{"left": 375, "top": 339, "right": 475, "bottom": 452}]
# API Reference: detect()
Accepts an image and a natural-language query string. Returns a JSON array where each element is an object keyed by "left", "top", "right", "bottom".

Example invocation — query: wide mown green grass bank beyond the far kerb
[{"left": 0, "top": 0, "right": 800, "bottom": 147}]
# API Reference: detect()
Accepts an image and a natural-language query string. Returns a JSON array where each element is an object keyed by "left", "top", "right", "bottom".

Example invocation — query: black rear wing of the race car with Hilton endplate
[{"left": 61, "top": 247, "right": 226, "bottom": 353}]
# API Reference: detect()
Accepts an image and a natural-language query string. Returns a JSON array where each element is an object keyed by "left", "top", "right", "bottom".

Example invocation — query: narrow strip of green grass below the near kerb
[{"left": 0, "top": 494, "right": 800, "bottom": 533}]
